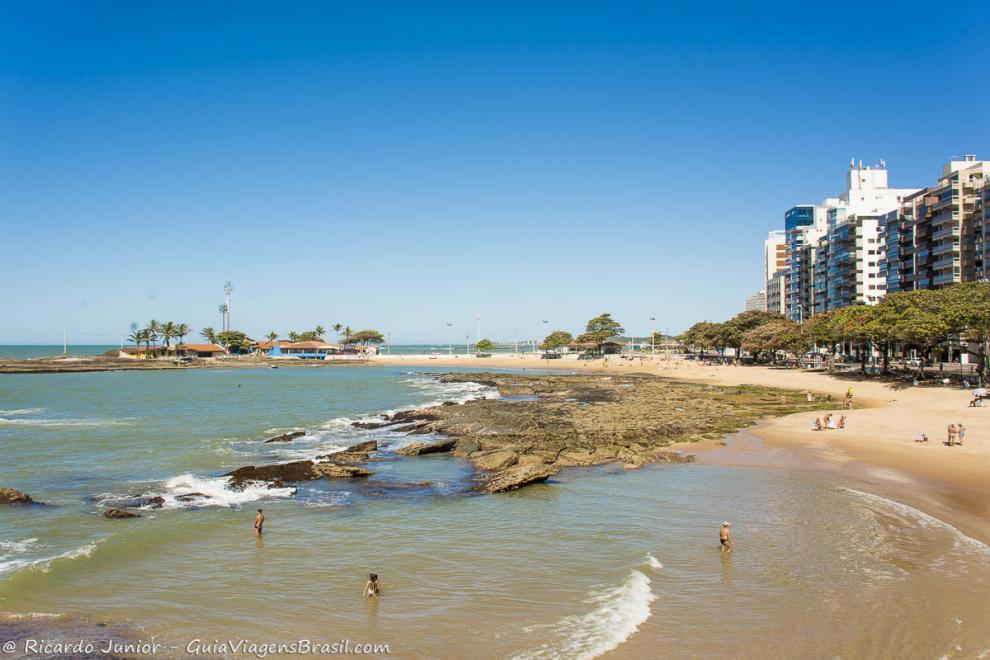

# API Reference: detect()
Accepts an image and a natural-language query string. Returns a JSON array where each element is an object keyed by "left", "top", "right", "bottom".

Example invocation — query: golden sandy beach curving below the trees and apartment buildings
[{"left": 371, "top": 354, "right": 990, "bottom": 541}]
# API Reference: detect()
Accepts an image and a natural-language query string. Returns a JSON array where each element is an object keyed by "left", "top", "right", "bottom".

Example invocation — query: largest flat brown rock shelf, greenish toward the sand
[{"left": 389, "top": 373, "right": 828, "bottom": 492}]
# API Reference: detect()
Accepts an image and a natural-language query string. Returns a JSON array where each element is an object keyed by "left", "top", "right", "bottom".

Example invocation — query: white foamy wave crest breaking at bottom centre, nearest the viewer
[{"left": 516, "top": 571, "right": 656, "bottom": 660}]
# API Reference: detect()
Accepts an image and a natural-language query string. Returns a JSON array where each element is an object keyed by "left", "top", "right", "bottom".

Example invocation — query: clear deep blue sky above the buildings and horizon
[{"left": 0, "top": 0, "right": 990, "bottom": 343}]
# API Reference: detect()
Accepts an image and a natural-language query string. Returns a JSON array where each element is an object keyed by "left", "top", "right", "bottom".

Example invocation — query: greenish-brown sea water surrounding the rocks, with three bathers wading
[{"left": 0, "top": 367, "right": 990, "bottom": 658}]
